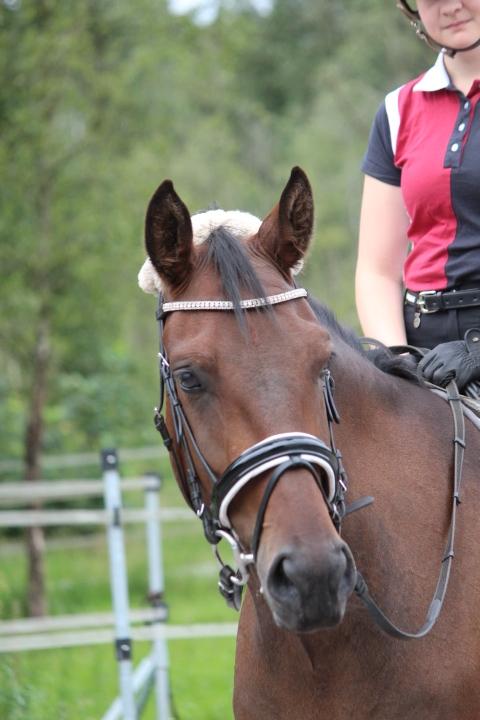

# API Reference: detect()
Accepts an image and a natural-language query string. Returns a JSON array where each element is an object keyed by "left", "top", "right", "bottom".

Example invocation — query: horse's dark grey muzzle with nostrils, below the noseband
[{"left": 262, "top": 538, "right": 356, "bottom": 632}]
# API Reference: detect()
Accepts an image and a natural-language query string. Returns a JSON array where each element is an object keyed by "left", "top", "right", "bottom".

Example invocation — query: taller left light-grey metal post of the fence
[{"left": 145, "top": 473, "right": 171, "bottom": 720}]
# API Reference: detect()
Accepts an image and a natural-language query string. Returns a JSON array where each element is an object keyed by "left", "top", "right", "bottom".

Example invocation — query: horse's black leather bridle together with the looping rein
[{"left": 154, "top": 288, "right": 465, "bottom": 640}]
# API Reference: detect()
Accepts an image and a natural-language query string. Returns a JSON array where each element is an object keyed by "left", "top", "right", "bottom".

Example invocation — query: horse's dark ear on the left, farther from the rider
[{"left": 145, "top": 180, "right": 193, "bottom": 287}]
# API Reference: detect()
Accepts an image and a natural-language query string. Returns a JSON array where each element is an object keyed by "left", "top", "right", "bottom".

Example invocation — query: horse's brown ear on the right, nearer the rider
[{"left": 258, "top": 167, "right": 313, "bottom": 274}]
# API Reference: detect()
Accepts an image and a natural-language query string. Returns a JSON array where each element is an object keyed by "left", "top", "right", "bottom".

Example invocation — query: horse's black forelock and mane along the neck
[{"left": 202, "top": 226, "right": 419, "bottom": 383}]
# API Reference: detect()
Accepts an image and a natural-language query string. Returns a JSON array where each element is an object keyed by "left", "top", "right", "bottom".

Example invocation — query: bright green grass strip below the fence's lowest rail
[{"left": 0, "top": 638, "right": 234, "bottom": 720}]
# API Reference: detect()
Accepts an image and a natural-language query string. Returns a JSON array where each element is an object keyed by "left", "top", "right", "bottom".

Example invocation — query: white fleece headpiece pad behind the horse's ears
[{"left": 138, "top": 210, "right": 262, "bottom": 295}]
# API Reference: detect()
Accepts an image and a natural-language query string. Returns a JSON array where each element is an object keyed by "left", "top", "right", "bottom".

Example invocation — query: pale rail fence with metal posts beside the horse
[{"left": 0, "top": 450, "right": 236, "bottom": 720}]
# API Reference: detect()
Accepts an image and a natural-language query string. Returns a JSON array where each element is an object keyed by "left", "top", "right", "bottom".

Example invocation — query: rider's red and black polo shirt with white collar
[{"left": 362, "top": 54, "right": 480, "bottom": 290}]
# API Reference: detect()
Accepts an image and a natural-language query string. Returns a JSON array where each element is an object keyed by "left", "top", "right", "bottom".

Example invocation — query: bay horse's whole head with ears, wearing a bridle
[{"left": 141, "top": 168, "right": 356, "bottom": 632}]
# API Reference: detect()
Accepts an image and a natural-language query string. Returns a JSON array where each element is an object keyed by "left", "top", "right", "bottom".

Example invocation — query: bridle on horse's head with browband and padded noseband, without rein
[{"left": 155, "top": 288, "right": 360, "bottom": 609}]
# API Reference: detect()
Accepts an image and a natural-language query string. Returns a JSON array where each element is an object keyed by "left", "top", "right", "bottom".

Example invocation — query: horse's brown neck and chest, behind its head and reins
[{"left": 236, "top": 349, "right": 480, "bottom": 720}]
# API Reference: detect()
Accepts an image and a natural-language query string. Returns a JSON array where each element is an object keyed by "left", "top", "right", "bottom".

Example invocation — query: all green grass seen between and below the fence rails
[{"left": 0, "top": 476, "right": 237, "bottom": 720}]
